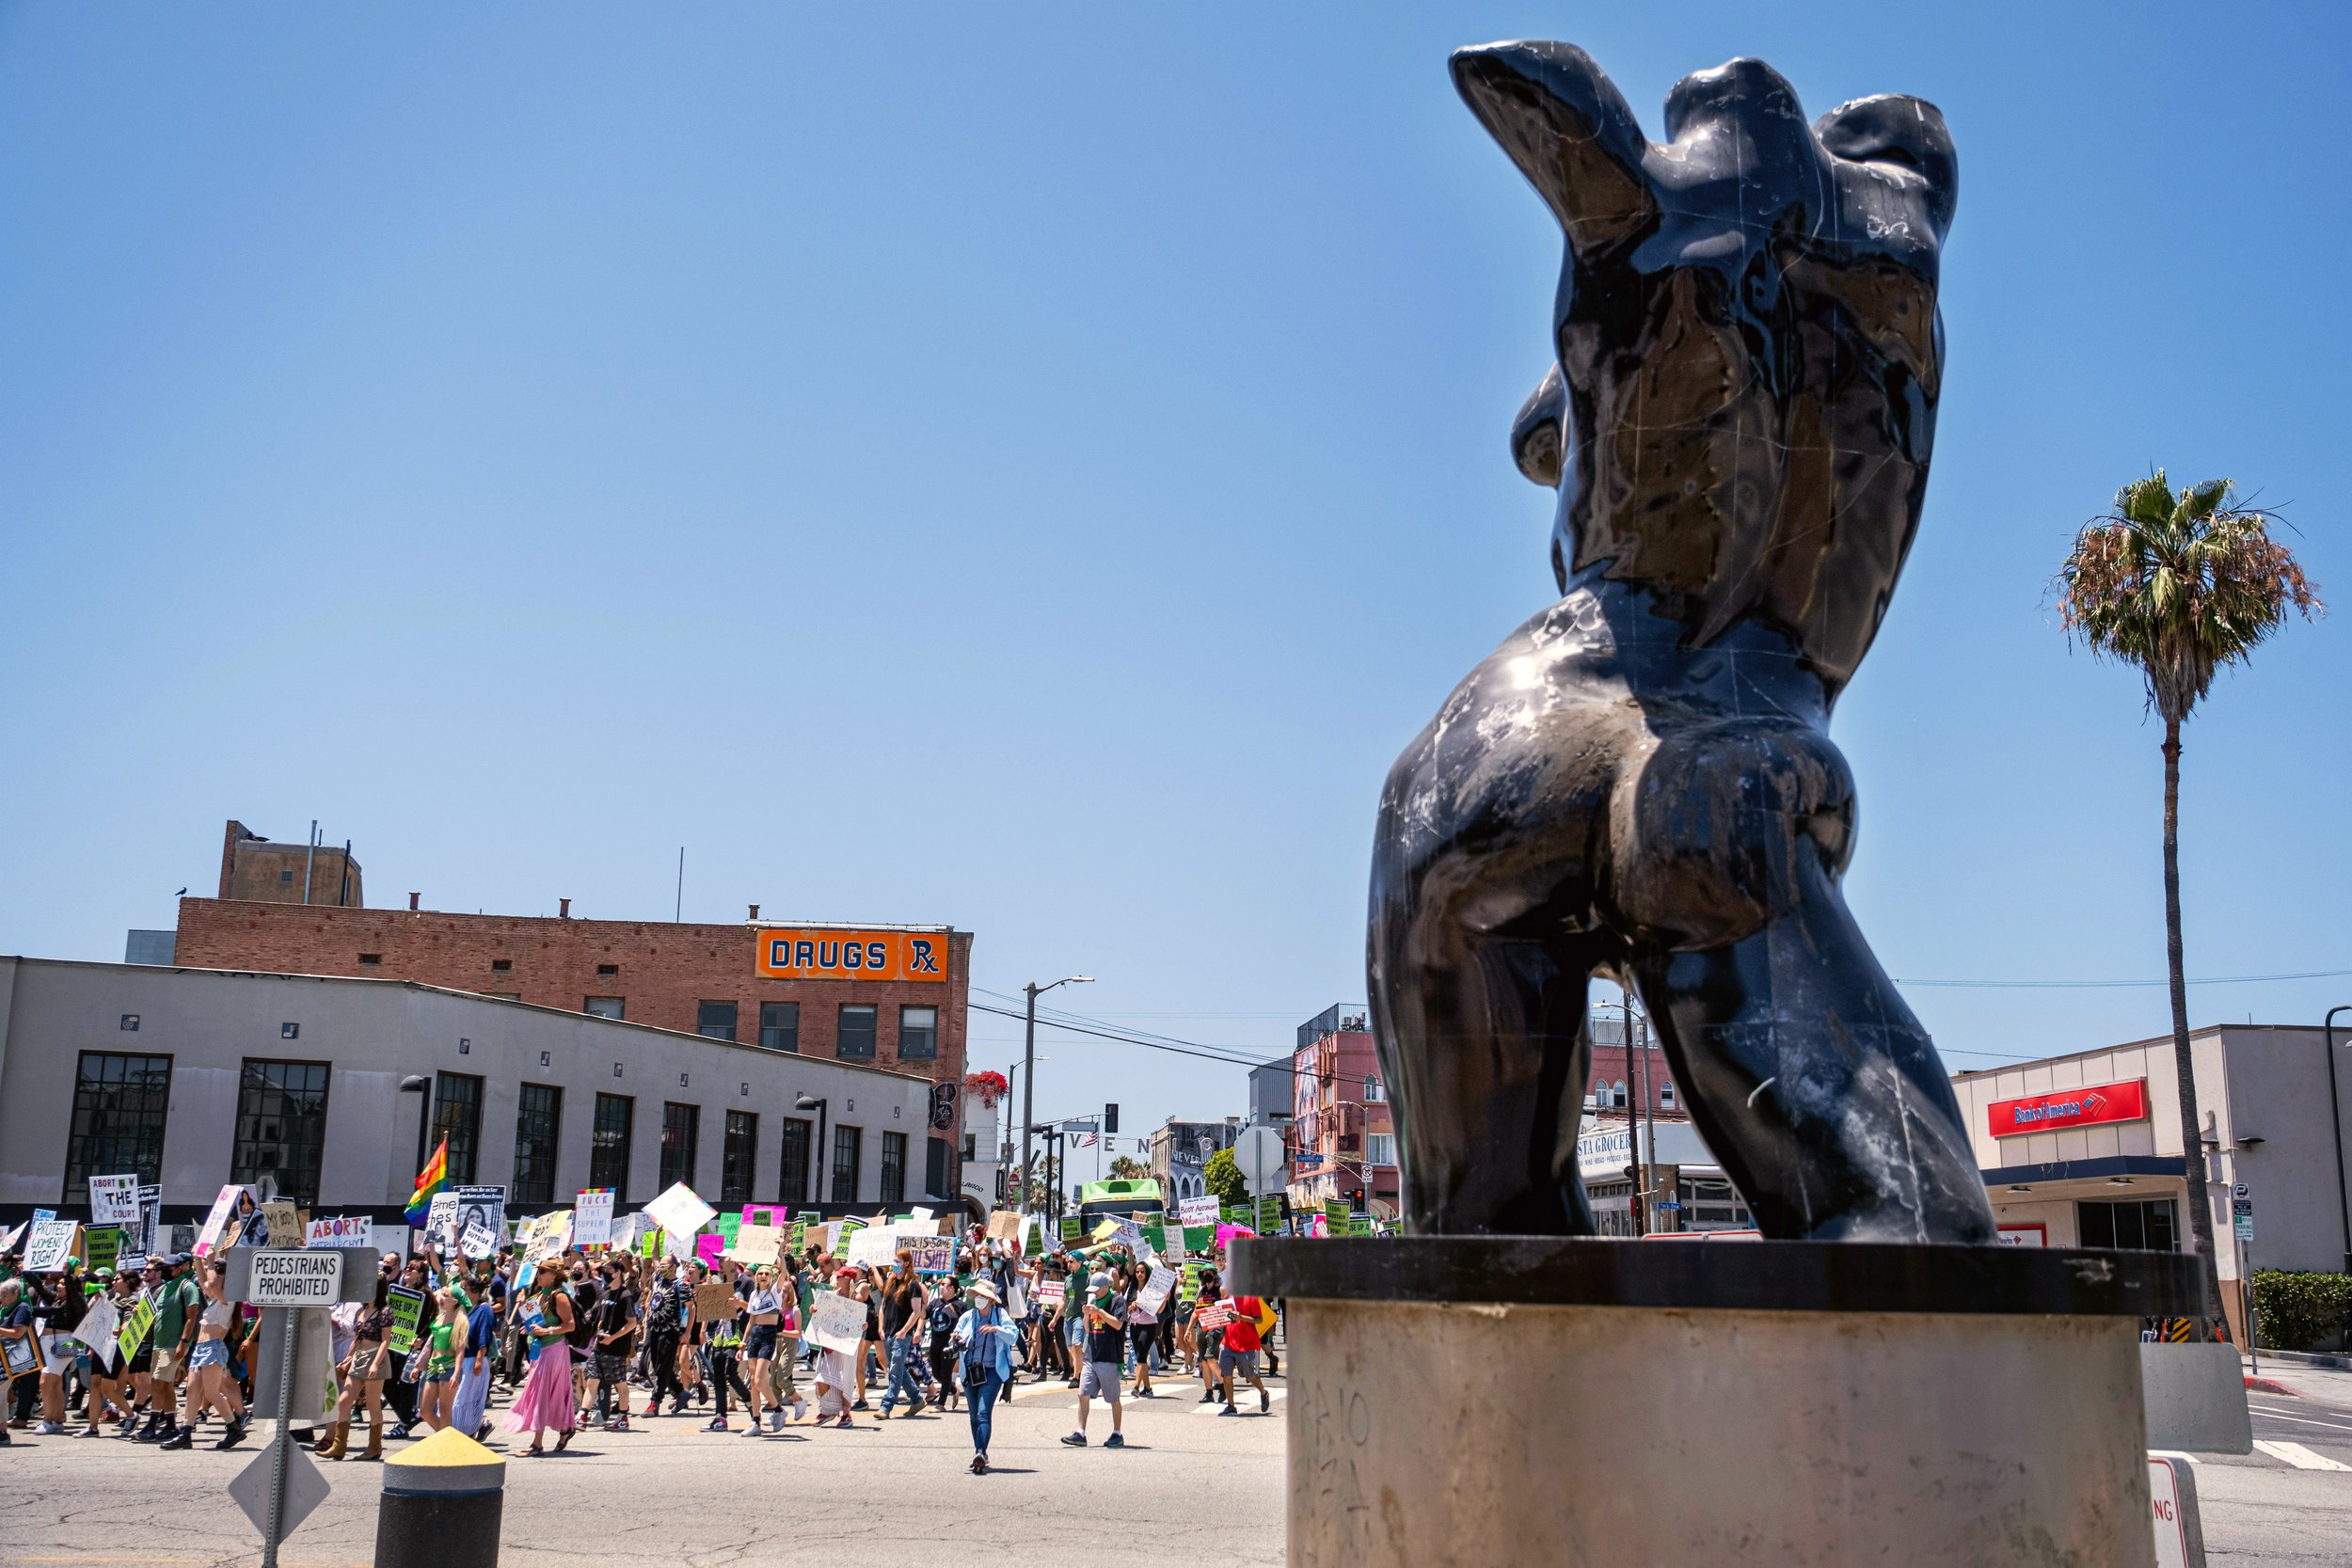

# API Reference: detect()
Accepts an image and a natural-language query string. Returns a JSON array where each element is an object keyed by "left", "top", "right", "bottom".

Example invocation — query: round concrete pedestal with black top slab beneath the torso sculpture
[{"left": 1235, "top": 1237, "right": 2197, "bottom": 1568}]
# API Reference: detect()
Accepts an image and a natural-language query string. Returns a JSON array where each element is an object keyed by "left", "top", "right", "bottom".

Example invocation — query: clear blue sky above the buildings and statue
[{"left": 0, "top": 2, "right": 2352, "bottom": 1165}]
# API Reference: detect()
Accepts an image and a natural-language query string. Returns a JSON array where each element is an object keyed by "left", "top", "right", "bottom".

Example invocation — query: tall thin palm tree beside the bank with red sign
[{"left": 2058, "top": 467, "right": 2322, "bottom": 1319}]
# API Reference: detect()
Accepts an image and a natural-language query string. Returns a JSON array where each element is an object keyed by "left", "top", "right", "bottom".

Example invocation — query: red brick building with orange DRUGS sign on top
[{"left": 174, "top": 823, "right": 972, "bottom": 1195}]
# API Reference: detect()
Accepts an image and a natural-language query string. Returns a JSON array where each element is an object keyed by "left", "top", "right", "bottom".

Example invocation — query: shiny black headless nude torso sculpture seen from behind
[{"left": 1372, "top": 42, "right": 1993, "bottom": 1242}]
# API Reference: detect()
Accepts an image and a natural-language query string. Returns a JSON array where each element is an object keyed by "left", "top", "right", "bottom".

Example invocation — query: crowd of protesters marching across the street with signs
[{"left": 0, "top": 1227, "right": 1279, "bottom": 1474}]
